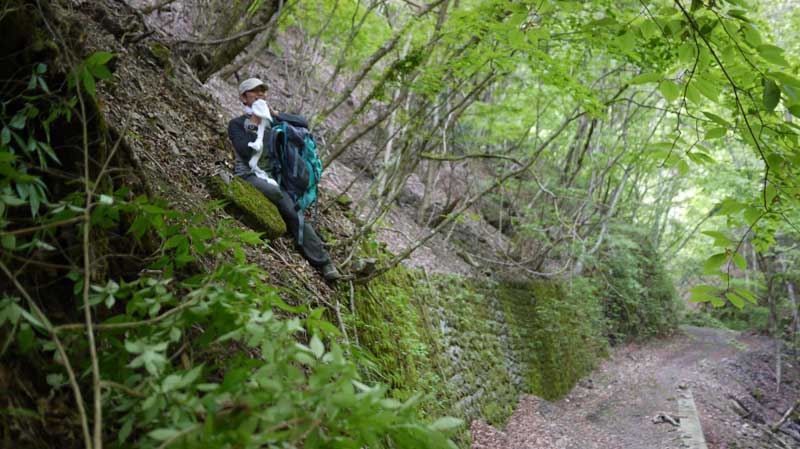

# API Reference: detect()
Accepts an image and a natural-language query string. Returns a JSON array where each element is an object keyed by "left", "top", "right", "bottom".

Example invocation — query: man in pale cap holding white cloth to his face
[{"left": 228, "top": 78, "right": 341, "bottom": 282}]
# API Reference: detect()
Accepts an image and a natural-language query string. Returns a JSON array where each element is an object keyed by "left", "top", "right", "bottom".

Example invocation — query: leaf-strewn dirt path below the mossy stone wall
[{"left": 471, "top": 326, "right": 800, "bottom": 449}]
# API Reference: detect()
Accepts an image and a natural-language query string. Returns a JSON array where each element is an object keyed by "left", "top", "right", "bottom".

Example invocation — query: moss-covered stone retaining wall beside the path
[{"left": 343, "top": 269, "right": 605, "bottom": 432}]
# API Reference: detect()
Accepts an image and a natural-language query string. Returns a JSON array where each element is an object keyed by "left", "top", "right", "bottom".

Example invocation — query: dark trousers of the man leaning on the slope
[{"left": 244, "top": 175, "right": 331, "bottom": 268}]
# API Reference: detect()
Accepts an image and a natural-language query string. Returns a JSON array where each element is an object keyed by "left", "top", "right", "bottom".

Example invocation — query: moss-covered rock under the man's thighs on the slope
[{"left": 208, "top": 173, "right": 286, "bottom": 240}]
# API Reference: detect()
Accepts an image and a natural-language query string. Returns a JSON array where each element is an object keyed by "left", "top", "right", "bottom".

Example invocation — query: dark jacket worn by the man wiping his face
[{"left": 228, "top": 113, "right": 308, "bottom": 176}]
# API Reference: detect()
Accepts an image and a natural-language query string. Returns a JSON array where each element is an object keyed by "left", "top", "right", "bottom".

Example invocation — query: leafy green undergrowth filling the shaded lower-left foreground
[{"left": 0, "top": 53, "right": 461, "bottom": 449}]
